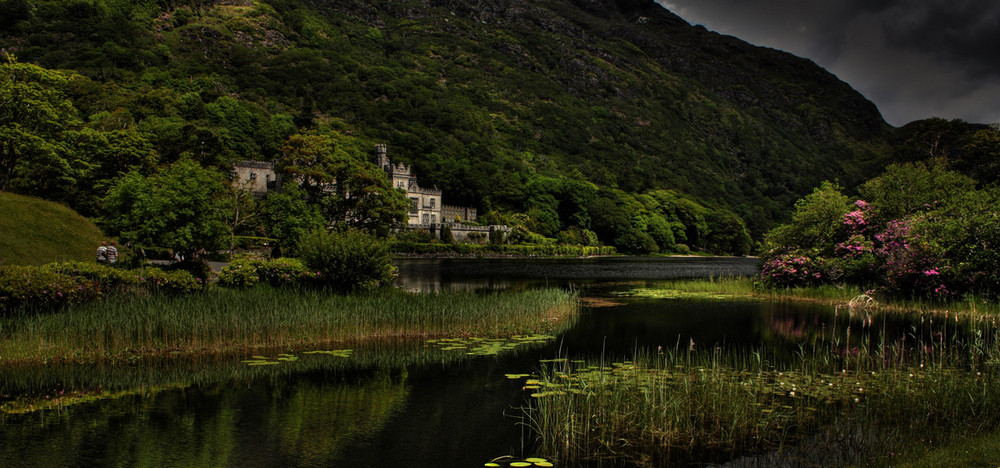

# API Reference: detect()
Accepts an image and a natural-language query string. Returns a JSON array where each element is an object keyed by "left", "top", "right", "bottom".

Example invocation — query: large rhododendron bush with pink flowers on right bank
[{"left": 761, "top": 163, "right": 1000, "bottom": 297}]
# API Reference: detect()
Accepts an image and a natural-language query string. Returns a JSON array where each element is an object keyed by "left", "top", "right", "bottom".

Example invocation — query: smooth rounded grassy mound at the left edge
[{"left": 0, "top": 192, "right": 105, "bottom": 265}]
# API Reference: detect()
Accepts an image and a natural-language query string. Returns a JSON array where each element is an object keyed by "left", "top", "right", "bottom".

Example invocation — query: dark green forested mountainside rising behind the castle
[{"left": 0, "top": 0, "right": 995, "bottom": 253}]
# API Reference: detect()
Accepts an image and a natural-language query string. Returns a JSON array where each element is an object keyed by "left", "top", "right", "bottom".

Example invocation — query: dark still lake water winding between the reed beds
[{"left": 0, "top": 258, "right": 884, "bottom": 467}]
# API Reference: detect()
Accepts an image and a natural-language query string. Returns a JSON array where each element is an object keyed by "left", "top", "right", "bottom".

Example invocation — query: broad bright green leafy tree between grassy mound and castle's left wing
[{"left": 102, "top": 159, "right": 228, "bottom": 253}]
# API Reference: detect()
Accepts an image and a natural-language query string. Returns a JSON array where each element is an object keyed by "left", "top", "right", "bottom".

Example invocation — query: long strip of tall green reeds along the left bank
[{"left": 0, "top": 286, "right": 577, "bottom": 365}]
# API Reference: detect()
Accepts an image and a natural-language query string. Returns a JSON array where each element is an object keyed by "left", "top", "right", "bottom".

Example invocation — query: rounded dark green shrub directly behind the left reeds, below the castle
[{"left": 299, "top": 228, "right": 396, "bottom": 291}]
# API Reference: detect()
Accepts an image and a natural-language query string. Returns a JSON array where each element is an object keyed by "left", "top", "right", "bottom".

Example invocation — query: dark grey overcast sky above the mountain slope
[{"left": 657, "top": 0, "right": 1000, "bottom": 126}]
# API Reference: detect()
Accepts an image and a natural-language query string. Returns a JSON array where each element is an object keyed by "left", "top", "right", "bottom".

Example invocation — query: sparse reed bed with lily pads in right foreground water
[{"left": 524, "top": 304, "right": 1000, "bottom": 466}]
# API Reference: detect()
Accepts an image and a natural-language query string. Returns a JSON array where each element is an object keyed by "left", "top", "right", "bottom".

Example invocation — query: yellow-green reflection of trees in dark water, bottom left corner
[{"left": 0, "top": 372, "right": 408, "bottom": 467}]
